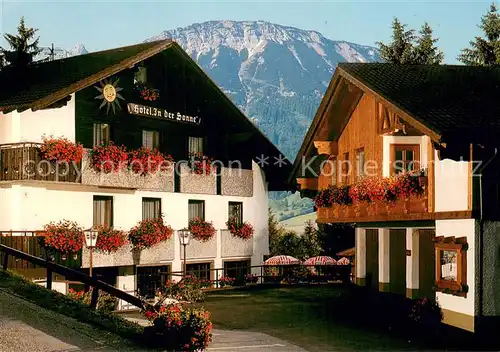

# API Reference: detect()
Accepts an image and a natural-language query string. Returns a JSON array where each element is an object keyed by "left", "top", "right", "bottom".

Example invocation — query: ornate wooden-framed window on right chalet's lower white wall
[{"left": 434, "top": 236, "right": 467, "bottom": 297}]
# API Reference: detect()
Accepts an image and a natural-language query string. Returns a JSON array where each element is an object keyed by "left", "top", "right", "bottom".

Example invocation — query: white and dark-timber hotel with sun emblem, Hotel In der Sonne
[{"left": 0, "top": 40, "right": 291, "bottom": 308}]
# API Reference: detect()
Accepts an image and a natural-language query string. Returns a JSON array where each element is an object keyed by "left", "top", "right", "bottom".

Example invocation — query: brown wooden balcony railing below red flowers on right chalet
[{"left": 317, "top": 176, "right": 431, "bottom": 223}]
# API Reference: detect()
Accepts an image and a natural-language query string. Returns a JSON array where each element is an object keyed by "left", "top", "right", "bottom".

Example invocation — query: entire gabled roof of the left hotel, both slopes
[{"left": 0, "top": 39, "right": 292, "bottom": 191}]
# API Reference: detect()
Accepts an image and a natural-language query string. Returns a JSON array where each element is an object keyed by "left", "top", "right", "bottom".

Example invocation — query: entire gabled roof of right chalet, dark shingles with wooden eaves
[{"left": 290, "top": 63, "right": 500, "bottom": 181}]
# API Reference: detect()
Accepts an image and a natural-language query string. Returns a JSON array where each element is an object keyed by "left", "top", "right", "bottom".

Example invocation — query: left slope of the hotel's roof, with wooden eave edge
[{"left": 0, "top": 40, "right": 173, "bottom": 111}]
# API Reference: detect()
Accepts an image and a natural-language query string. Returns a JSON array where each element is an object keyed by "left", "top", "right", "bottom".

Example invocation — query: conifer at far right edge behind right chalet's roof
[{"left": 458, "top": 3, "right": 500, "bottom": 66}]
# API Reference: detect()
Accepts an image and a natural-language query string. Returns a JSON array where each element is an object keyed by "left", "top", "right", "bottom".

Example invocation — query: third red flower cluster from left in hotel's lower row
[{"left": 128, "top": 217, "right": 174, "bottom": 249}]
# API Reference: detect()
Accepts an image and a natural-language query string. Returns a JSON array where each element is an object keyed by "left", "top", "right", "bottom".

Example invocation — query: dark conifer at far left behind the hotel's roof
[{"left": 0, "top": 17, "right": 41, "bottom": 66}]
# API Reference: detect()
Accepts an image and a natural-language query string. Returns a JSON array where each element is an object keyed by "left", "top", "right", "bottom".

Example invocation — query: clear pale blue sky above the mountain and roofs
[{"left": 0, "top": 0, "right": 491, "bottom": 64}]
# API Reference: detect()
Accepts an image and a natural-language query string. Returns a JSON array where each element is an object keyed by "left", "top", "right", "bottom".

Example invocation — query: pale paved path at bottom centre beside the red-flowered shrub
[{"left": 126, "top": 317, "right": 307, "bottom": 352}]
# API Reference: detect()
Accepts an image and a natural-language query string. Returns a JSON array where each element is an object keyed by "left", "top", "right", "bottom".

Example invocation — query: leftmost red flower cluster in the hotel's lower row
[{"left": 41, "top": 220, "right": 85, "bottom": 253}]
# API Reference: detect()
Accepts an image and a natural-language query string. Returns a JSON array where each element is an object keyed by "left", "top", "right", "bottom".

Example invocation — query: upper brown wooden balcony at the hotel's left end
[{"left": 0, "top": 142, "right": 81, "bottom": 183}]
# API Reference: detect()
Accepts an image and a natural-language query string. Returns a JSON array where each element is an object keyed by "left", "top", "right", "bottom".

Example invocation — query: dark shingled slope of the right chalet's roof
[{"left": 339, "top": 63, "right": 500, "bottom": 141}]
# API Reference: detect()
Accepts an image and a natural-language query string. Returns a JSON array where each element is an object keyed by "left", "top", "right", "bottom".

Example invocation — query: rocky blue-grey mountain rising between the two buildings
[{"left": 146, "top": 21, "right": 380, "bottom": 220}]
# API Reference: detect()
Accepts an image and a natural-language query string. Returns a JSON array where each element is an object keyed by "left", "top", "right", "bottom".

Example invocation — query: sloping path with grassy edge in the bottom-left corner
[{"left": 0, "top": 289, "right": 143, "bottom": 352}]
